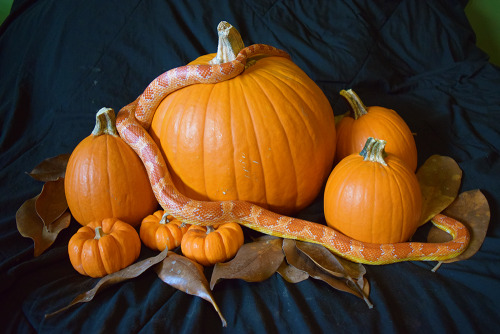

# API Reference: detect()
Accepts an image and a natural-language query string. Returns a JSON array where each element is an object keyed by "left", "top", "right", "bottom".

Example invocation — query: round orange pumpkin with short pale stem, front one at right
[{"left": 324, "top": 138, "right": 422, "bottom": 243}]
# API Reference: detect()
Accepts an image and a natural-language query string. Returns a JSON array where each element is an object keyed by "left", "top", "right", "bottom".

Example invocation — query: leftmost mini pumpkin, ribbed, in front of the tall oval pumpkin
[{"left": 68, "top": 218, "right": 141, "bottom": 277}]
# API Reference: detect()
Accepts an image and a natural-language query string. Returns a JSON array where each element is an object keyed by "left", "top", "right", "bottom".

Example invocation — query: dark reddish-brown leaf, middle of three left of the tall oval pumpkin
[{"left": 35, "top": 178, "right": 68, "bottom": 229}]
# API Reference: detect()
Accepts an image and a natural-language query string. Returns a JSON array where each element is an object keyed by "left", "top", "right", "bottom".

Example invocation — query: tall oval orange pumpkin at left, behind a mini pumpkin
[{"left": 64, "top": 108, "right": 158, "bottom": 226}]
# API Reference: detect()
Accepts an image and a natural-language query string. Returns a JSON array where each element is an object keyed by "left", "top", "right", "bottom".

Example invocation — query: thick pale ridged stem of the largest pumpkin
[{"left": 209, "top": 21, "right": 245, "bottom": 65}]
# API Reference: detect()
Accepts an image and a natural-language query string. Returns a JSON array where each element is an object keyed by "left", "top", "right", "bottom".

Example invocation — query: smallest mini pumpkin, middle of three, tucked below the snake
[{"left": 139, "top": 210, "right": 190, "bottom": 251}]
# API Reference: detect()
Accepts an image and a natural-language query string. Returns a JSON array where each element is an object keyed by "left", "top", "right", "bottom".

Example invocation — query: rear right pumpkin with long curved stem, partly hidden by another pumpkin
[{"left": 335, "top": 89, "right": 417, "bottom": 171}]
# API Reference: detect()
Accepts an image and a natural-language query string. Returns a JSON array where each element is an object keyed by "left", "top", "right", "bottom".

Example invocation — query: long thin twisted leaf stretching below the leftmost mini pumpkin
[{"left": 45, "top": 249, "right": 168, "bottom": 318}]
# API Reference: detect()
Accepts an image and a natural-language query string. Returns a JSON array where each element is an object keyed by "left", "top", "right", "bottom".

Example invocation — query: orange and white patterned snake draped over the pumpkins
[{"left": 117, "top": 44, "right": 469, "bottom": 264}]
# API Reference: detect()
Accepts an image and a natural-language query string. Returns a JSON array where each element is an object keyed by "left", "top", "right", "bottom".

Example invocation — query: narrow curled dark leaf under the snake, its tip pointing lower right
[{"left": 283, "top": 239, "right": 373, "bottom": 308}]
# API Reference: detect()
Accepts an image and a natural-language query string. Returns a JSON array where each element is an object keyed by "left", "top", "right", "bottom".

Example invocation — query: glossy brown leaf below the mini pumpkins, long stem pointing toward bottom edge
[{"left": 155, "top": 252, "right": 227, "bottom": 327}]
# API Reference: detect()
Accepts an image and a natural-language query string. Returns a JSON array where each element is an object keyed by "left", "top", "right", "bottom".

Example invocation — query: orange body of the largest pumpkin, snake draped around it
[{"left": 150, "top": 22, "right": 335, "bottom": 214}]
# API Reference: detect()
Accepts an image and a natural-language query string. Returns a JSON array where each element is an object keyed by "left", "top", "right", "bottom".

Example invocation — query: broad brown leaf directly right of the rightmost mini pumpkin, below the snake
[{"left": 210, "top": 238, "right": 284, "bottom": 289}]
